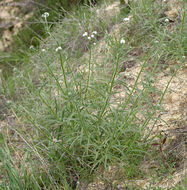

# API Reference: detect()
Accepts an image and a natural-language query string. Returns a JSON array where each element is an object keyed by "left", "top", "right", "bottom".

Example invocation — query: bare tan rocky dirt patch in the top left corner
[{"left": 0, "top": 0, "right": 34, "bottom": 51}]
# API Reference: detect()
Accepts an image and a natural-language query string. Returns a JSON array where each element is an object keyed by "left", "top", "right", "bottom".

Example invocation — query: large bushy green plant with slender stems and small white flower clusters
[{"left": 1, "top": 1, "right": 185, "bottom": 189}]
